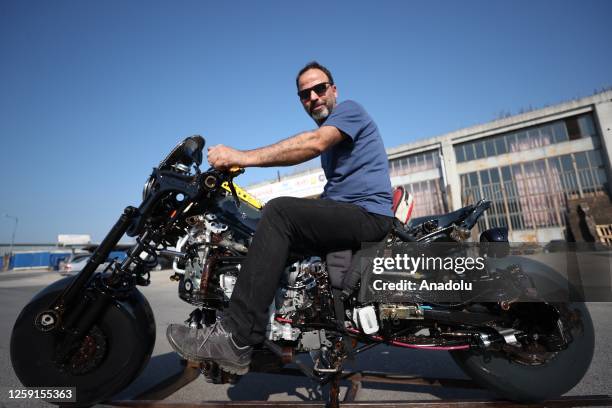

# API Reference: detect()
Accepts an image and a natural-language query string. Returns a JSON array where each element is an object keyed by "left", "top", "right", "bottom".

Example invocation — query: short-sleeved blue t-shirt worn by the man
[{"left": 321, "top": 100, "right": 393, "bottom": 217}]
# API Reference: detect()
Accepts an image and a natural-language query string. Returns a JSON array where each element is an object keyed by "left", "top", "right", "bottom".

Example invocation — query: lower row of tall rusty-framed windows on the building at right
[{"left": 461, "top": 150, "right": 607, "bottom": 230}]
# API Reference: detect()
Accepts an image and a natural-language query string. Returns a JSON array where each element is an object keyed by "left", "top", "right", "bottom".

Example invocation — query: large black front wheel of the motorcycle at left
[{"left": 11, "top": 277, "right": 155, "bottom": 407}]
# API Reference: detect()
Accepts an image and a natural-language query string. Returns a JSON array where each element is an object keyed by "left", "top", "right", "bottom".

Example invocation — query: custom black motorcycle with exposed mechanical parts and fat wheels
[{"left": 10, "top": 136, "right": 594, "bottom": 406}]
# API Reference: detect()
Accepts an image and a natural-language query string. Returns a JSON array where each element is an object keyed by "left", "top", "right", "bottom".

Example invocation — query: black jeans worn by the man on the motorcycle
[{"left": 223, "top": 197, "right": 392, "bottom": 344}]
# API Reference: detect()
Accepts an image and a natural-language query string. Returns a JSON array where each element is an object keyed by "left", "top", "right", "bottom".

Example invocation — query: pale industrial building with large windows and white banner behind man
[{"left": 248, "top": 91, "right": 612, "bottom": 242}]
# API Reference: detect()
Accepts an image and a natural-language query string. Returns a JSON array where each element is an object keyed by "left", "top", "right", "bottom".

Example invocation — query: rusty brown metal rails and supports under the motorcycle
[{"left": 103, "top": 360, "right": 612, "bottom": 408}]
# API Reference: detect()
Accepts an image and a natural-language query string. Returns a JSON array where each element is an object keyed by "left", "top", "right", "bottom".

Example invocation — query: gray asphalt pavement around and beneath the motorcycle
[{"left": 0, "top": 270, "right": 612, "bottom": 408}]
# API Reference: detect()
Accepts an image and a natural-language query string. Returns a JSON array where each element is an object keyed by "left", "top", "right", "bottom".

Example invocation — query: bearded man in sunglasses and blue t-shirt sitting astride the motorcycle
[{"left": 167, "top": 62, "right": 393, "bottom": 374}]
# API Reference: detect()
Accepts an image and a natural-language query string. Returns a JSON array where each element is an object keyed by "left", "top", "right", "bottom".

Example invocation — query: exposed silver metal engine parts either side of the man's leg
[{"left": 174, "top": 213, "right": 332, "bottom": 350}]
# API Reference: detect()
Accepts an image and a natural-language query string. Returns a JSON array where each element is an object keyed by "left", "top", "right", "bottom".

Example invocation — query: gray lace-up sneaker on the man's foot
[{"left": 166, "top": 321, "right": 253, "bottom": 375}]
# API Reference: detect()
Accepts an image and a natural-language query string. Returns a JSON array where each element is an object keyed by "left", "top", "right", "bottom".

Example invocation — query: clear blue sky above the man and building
[{"left": 0, "top": 0, "right": 612, "bottom": 243}]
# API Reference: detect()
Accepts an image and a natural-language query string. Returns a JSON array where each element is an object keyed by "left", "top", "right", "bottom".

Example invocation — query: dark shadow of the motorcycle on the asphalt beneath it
[{"left": 113, "top": 346, "right": 496, "bottom": 401}]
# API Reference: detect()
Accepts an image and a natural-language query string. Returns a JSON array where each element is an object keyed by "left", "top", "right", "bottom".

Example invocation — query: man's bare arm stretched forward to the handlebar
[{"left": 208, "top": 126, "right": 348, "bottom": 169}]
